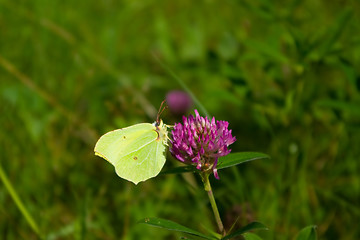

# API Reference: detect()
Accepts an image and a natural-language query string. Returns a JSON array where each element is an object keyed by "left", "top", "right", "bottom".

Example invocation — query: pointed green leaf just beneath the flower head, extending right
[{"left": 217, "top": 152, "right": 270, "bottom": 169}]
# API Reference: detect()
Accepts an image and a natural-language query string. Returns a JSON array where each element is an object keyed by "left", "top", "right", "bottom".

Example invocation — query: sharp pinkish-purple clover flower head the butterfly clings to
[{"left": 170, "top": 110, "right": 236, "bottom": 179}]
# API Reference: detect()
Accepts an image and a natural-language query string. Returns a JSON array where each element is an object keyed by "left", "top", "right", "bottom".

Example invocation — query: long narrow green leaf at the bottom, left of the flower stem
[{"left": 138, "top": 218, "right": 215, "bottom": 240}]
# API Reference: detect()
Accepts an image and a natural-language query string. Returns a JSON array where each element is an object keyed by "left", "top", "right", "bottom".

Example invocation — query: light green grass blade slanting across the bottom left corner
[{"left": 0, "top": 165, "right": 41, "bottom": 238}]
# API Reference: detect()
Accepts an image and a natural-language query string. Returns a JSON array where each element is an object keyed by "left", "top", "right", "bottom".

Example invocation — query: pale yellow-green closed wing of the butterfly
[{"left": 95, "top": 123, "right": 166, "bottom": 184}]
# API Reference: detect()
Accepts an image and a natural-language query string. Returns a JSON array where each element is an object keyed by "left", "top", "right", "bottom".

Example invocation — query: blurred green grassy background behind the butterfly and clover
[{"left": 0, "top": 0, "right": 360, "bottom": 240}]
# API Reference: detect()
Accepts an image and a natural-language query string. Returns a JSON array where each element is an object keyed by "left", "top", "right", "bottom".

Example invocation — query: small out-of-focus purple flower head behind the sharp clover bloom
[{"left": 166, "top": 90, "right": 193, "bottom": 115}]
